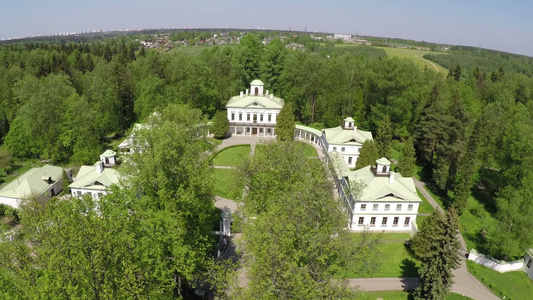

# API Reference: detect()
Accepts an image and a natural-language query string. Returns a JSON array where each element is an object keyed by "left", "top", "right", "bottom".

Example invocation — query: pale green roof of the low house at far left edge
[{"left": 0, "top": 165, "right": 63, "bottom": 199}]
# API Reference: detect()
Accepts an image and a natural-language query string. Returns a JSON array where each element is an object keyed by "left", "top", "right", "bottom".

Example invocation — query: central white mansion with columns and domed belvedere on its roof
[{"left": 226, "top": 79, "right": 285, "bottom": 136}]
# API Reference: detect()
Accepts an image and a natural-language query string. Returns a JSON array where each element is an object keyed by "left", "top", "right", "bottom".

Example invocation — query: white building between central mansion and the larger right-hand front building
[{"left": 322, "top": 117, "right": 372, "bottom": 168}]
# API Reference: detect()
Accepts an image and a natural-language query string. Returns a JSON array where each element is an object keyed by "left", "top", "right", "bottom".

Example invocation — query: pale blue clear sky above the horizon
[{"left": 0, "top": 0, "right": 533, "bottom": 56}]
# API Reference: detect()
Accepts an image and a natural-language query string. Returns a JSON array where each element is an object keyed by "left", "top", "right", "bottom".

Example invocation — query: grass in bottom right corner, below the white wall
[{"left": 466, "top": 261, "right": 533, "bottom": 299}]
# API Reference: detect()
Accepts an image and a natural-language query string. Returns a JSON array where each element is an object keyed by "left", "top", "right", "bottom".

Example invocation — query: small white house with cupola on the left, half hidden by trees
[{"left": 69, "top": 160, "right": 119, "bottom": 199}]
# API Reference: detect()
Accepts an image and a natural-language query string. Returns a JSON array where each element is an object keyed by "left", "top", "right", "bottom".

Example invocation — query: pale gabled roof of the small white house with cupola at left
[{"left": 68, "top": 164, "right": 119, "bottom": 190}]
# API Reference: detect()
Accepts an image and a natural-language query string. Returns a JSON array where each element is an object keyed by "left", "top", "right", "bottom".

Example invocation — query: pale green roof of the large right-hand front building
[{"left": 345, "top": 166, "right": 422, "bottom": 202}]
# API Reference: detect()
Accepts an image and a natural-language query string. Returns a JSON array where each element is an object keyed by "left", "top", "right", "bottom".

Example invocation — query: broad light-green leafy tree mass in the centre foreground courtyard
[{"left": 235, "top": 142, "right": 376, "bottom": 299}]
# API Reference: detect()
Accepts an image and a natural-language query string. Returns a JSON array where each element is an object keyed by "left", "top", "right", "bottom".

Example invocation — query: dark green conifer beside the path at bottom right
[{"left": 411, "top": 208, "right": 461, "bottom": 299}]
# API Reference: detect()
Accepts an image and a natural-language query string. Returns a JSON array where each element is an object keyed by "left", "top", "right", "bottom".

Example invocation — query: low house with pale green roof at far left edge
[{"left": 0, "top": 165, "right": 63, "bottom": 208}]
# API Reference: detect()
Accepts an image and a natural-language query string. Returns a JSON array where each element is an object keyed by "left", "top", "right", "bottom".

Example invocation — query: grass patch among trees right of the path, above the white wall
[{"left": 459, "top": 197, "right": 498, "bottom": 253}]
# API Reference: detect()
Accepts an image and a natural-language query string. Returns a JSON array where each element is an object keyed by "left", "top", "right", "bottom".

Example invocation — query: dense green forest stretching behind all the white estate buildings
[{"left": 0, "top": 33, "right": 533, "bottom": 264}]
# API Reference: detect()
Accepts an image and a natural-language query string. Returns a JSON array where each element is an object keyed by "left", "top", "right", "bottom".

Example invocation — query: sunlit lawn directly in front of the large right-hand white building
[{"left": 341, "top": 233, "right": 420, "bottom": 278}]
